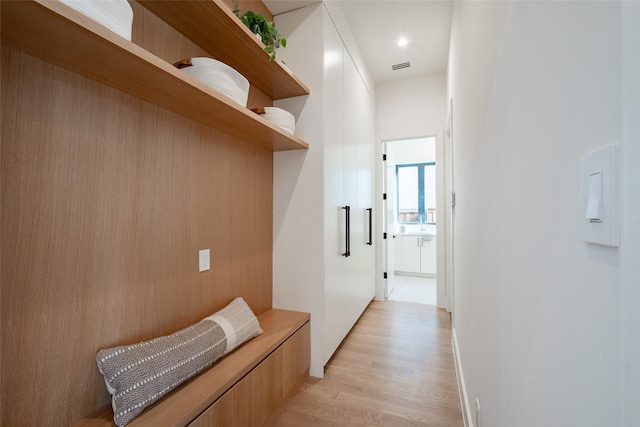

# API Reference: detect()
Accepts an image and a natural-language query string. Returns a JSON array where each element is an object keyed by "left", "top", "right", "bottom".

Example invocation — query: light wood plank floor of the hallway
[{"left": 274, "top": 301, "right": 463, "bottom": 427}]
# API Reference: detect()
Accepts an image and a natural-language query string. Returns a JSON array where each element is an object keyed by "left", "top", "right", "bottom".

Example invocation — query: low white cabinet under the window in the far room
[{"left": 395, "top": 235, "right": 436, "bottom": 276}]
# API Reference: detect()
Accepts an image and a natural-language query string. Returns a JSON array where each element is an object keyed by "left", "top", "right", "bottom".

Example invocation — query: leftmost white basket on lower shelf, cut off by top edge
[{"left": 60, "top": 0, "right": 133, "bottom": 41}]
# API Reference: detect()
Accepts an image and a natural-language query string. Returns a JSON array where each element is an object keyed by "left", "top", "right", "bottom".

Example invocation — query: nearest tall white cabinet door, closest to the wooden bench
[{"left": 323, "top": 12, "right": 350, "bottom": 363}]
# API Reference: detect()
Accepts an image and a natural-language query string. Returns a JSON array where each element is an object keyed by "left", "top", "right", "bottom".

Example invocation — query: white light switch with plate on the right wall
[{"left": 580, "top": 145, "right": 620, "bottom": 247}]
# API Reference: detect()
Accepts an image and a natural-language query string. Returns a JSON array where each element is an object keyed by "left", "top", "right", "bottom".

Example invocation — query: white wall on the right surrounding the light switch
[{"left": 448, "top": 2, "right": 640, "bottom": 427}]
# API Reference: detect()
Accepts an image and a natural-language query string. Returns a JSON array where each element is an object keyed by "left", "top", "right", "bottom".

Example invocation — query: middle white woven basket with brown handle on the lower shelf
[{"left": 174, "top": 58, "right": 249, "bottom": 107}]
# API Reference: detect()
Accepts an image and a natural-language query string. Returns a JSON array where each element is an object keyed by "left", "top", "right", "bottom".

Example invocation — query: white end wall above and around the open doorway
[{"left": 376, "top": 73, "right": 447, "bottom": 306}]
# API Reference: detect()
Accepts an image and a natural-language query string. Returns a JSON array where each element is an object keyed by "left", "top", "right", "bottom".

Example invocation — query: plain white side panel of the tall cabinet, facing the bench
[{"left": 273, "top": 5, "right": 324, "bottom": 377}]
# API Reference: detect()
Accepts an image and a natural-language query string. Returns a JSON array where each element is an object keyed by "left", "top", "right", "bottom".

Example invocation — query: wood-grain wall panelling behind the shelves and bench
[{"left": 0, "top": 3, "right": 273, "bottom": 426}]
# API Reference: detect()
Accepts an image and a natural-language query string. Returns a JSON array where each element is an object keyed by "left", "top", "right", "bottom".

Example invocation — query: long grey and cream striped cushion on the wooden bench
[{"left": 96, "top": 298, "right": 262, "bottom": 426}]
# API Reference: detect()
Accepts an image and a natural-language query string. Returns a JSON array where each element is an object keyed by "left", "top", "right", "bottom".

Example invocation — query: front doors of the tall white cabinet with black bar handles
[{"left": 323, "top": 12, "right": 375, "bottom": 363}]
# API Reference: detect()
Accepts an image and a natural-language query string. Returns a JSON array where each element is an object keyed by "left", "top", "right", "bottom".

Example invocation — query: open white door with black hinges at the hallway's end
[{"left": 382, "top": 142, "right": 396, "bottom": 298}]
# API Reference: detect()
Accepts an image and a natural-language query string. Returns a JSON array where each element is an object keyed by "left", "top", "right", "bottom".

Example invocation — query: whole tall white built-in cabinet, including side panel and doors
[{"left": 273, "top": 4, "right": 376, "bottom": 377}]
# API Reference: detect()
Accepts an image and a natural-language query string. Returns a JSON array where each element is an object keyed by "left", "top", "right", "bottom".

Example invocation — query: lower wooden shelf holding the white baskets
[{"left": 1, "top": 0, "right": 309, "bottom": 151}]
